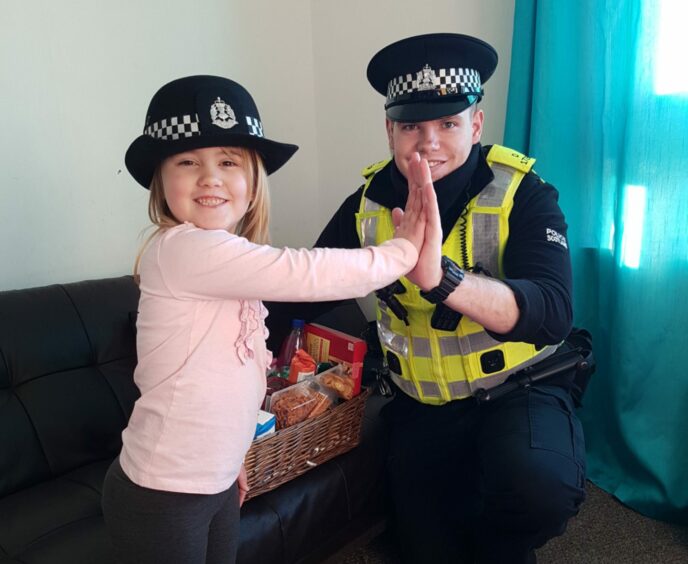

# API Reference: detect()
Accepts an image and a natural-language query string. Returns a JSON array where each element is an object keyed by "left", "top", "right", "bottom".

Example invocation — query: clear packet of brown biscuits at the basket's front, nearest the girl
[{"left": 270, "top": 380, "right": 336, "bottom": 430}]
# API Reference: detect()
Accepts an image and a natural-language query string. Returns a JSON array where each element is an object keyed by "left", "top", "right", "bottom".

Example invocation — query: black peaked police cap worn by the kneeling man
[{"left": 367, "top": 33, "right": 497, "bottom": 122}]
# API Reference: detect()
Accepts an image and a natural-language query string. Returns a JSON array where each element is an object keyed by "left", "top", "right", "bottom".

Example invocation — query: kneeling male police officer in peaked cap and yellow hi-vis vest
[{"left": 317, "top": 33, "right": 585, "bottom": 564}]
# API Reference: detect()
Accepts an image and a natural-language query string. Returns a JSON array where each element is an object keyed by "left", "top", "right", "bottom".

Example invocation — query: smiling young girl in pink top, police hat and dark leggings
[{"left": 103, "top": 76, "right": 439, "bottom": 564}]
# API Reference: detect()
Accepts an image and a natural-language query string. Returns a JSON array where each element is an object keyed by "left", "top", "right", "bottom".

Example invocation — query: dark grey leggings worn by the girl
[{"left": 102, "top": 458, "right": 239, "bottom": 564}]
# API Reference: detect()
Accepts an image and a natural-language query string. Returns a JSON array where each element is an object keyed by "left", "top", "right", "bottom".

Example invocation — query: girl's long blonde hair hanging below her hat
[{"left": 134, "top": 147, "right": 270, "bottom": 281}]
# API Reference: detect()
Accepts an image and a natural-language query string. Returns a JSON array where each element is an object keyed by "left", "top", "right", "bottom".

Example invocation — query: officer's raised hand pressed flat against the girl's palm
[{"left": 406, "top": 153, "right": 442, "bottom": 291}]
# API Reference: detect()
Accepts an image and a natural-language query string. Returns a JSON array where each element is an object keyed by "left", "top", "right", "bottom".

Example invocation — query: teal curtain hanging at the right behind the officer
[{"left": 506, "top": 0, "right": 688, "bottom": 524}]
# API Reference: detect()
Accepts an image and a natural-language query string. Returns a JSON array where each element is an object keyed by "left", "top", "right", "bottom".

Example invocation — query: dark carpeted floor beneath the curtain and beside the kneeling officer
[{"left": 328, "top": 483, "right": 688, "bottom": 564}]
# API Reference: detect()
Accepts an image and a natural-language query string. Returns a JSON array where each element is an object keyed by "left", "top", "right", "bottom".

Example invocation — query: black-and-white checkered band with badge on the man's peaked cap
[{"left": 387, "top": 67, "right": 482, "bottom": 104}]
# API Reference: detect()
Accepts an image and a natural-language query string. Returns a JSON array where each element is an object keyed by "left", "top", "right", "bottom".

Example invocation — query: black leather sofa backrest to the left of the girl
[{"left": 0, "top": 276, "right": 138, "bottom": 496}]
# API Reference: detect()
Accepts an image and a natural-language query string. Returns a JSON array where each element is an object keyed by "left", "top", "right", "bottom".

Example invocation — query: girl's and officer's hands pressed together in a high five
[{"left": 392, "top": 153, "right": 442, "bottom": 291}]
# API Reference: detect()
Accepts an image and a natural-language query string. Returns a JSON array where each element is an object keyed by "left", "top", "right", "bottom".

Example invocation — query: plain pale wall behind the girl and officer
[{"left": 0, "top": 0, "right": 513, "bottom": 290}]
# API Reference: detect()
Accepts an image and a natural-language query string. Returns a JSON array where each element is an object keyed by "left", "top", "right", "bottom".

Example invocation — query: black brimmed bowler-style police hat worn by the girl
[{"left": 124, "top": 75, "right": 298, "bottom": 188}]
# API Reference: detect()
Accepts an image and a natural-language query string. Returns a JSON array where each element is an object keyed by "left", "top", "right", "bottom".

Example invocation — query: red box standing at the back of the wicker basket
[{"left": 305, "top": 323, "right": 368, "bottom": 396}]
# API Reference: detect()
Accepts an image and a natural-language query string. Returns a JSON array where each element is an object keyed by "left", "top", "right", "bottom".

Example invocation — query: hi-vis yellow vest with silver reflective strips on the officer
[{"left": 356, "top": 145, "right": 557, "bottom": 405}]
